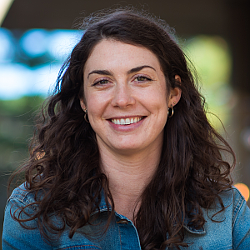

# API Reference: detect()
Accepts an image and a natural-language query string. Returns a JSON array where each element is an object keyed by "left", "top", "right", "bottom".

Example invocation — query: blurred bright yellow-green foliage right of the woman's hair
[{"left": 184, "top": 35, "right": 233, "bottom": 129}]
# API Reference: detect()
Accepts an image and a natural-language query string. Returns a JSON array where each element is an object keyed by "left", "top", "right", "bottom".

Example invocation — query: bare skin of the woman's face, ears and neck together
[{"left": 80, "top": 39, "right": 181, "bottom": 220}]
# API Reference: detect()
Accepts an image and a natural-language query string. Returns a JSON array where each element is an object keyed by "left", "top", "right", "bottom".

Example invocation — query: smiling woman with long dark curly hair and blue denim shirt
[{"left": 3, "top": 10, "right": 250, "bottom": 250}]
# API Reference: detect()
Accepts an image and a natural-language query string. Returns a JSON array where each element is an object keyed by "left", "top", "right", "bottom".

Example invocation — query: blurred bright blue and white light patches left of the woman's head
[{"left": 0, "top": 28, "right": 82, "bottom": 100}]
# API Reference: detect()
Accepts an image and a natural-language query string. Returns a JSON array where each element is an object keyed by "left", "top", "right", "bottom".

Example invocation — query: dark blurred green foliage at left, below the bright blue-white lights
[{"left": 0, "top": 96, "right": 44, "bottom": 171}]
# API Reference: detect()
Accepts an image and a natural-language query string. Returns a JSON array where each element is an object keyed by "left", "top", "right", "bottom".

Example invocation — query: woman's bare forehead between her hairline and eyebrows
[{"left": 84, "top": 39, "right": 161, "bottom": 71}]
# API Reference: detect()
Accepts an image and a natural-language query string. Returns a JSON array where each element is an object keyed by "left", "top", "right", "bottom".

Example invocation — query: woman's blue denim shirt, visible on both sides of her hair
[{"left": 2, "top": 185, "right": 250, "bottom": 250}]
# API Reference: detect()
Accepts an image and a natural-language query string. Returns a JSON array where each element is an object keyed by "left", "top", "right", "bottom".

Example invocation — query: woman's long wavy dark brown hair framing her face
[{"left": 13, "top": 9, "right": 235, "bottom": 250}]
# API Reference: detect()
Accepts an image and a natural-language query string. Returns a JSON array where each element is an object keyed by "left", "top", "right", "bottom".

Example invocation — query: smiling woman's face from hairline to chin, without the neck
[{"left": 81, "top": 39, "right": 177, "bottom": 154}]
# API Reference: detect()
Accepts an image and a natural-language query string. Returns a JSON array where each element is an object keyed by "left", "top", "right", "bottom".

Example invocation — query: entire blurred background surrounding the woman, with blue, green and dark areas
[{"left": 0, "top": 0, "right": 250, "bottom": 246}]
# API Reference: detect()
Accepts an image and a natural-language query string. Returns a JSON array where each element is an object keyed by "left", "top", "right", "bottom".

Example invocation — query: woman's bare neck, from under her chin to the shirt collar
[{"left": 100, "top": 146, "right": 161, "bottom": 220}]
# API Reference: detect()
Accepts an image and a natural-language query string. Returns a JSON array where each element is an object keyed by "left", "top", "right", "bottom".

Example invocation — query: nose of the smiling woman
[{"left": 112, "top": 83, "right": 135, "bottom": 108}]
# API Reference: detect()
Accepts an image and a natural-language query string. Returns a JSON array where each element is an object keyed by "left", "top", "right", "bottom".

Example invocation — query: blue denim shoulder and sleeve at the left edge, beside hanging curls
[{"left": 2, "top": 183, "right": 50, "bottom": 250}]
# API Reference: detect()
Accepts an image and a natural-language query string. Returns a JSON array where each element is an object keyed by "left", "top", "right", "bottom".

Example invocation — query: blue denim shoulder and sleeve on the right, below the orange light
[{"left": 185, "top": 187, "right": 250, "bottom": 250}]
